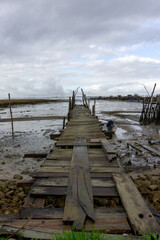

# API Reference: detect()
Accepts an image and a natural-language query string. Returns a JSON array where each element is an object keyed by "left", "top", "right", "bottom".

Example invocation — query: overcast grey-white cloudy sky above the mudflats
[{"left": 0, "top": 0, "right": 160, "bottom": 98}]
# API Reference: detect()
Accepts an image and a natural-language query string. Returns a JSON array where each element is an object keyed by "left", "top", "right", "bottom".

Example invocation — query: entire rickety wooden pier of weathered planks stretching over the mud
[{"left": 0, "top": 92, "right": 160, "bottom": 239}]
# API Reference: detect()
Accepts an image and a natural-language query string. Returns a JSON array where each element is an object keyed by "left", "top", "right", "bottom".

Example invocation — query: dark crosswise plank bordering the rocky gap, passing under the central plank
[{"left": 30, "top": 186, "right": 118, "bottom": 197}]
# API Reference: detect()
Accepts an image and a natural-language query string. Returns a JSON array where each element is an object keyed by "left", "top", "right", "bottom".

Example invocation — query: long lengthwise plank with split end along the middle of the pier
[{"left": 63, "top": 138, "right": 95, "bottom": 230}]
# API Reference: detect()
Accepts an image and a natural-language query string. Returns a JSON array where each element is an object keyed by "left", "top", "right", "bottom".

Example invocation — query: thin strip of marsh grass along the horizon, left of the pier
[{"left": 0, "top": 99, "right": 68, "bottom": 107}]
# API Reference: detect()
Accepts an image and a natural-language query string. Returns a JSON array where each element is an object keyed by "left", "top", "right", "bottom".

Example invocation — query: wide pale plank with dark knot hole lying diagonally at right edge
[{"left": 113, "top": 173, "right": 160, "bottom": 234}]
